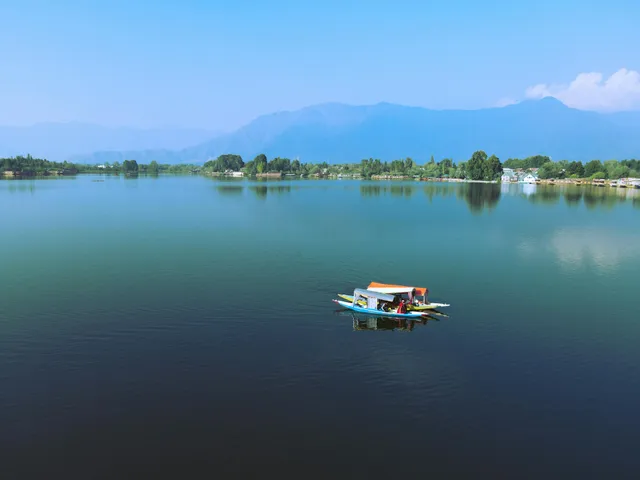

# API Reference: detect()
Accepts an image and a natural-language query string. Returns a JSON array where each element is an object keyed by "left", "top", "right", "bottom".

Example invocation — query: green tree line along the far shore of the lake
[{"left": 5, "top": 150, "right": 640, "bottom": 181}]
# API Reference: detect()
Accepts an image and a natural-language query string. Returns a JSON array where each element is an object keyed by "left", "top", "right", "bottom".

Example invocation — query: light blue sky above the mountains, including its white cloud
[{"left": 0, "top": 0, "right": 640, "bottom": 131}]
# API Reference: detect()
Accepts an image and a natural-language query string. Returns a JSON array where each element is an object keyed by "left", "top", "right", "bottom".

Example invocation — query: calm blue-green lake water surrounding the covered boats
[{"left": 0, "top": 176, "right": 640, "bottom": 478}]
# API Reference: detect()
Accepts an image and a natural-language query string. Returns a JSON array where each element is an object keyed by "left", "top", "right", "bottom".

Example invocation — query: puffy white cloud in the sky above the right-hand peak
[{"left": 525, "top": 68, "right": 640, "bottom": 112}]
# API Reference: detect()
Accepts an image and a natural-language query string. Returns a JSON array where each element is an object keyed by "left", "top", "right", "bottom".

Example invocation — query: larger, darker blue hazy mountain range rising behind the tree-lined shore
[{"left": 0, "top": 97, "right": 640, "bottom": 163}]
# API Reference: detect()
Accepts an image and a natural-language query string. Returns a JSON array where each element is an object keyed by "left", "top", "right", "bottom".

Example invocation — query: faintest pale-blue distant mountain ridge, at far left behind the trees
[{"left": 0, "top": 122, "right": 215, "bottom": 161}]
